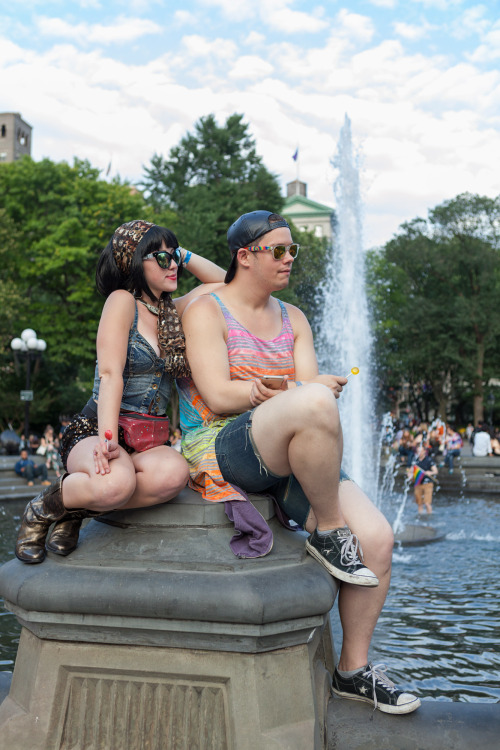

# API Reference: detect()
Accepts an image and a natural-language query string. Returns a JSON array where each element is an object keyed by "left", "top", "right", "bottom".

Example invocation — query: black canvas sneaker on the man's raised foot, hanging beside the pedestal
[{"left": 306, "top": 526, "right": 378, "bottom": 586}]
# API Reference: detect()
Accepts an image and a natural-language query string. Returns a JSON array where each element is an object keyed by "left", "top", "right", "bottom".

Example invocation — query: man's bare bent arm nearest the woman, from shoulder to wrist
[{"left": 182, "top": 295, "right": 266, "bottom": 414}]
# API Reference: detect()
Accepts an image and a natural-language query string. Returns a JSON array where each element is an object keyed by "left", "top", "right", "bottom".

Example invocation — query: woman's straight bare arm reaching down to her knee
[{"left": 95, "top": 289, "right": 135, "bottom": 474}]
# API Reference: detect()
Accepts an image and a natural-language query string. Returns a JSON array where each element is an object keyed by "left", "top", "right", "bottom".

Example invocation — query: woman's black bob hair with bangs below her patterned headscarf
[{"left": 95, "top": 224, "right": 183, "bottom": 301}]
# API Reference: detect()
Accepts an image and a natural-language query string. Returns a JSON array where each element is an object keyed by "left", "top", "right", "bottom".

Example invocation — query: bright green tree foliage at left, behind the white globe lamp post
[{"left": 0, "top": 157, "right": 148, "bottom": 432}]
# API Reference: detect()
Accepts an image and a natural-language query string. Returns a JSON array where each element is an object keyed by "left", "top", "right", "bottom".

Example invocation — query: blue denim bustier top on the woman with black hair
[{"left": 92, "top": 302, "right": 172, "bottom": 415}]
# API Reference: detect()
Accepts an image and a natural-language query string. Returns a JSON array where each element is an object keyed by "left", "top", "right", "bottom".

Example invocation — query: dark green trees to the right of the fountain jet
[{"left": 369, "top": 193, "right": 500, "bottom": 422}]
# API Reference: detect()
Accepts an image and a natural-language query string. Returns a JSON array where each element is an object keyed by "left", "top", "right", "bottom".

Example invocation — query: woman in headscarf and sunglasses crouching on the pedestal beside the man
[{"left": 16, "top": 220, "right": 224, "bottom": 563}]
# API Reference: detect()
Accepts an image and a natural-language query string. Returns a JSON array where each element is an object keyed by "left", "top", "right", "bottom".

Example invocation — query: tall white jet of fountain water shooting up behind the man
[{"left": 316, "top": 115, "right": 379, "bottom": 501}]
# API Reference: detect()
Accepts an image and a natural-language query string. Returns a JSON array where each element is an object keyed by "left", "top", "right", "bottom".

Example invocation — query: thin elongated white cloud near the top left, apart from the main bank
[{"left": 37, "top": 16, "right": 162, "bottom": 44}]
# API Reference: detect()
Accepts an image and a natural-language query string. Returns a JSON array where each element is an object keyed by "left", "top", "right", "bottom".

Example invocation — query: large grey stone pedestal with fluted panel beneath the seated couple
[{"left": 0, "top": 490, "right": 337, "bottom": 750}]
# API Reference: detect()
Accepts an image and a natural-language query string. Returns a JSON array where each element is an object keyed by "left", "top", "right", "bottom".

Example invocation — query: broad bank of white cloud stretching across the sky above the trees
[{"left": 0, "top": 0, "right": 500, "bottom": 250}]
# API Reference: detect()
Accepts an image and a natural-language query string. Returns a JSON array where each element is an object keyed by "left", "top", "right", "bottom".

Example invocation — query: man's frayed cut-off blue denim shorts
[{"left": 215, "top": 410, "right": 349, "bottom": 528}]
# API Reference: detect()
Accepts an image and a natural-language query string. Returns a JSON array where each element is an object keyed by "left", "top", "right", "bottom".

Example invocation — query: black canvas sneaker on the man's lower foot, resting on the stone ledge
[{"left": 332, "top": 664, "right": 420, "bottom": 714}]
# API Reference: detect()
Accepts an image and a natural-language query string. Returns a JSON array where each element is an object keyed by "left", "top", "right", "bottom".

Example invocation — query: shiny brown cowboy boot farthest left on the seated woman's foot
[{"left": 16, "top": 474, "right": 68, "bottom": 563}]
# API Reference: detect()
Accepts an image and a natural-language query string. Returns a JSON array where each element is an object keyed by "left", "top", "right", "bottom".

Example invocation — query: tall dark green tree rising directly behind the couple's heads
[{"left": 142, "top": 114, "right": 283, "bottom": 282}]
